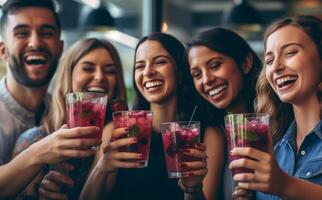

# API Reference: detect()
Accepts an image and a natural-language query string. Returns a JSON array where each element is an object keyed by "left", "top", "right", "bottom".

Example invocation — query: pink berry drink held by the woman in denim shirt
[{"left": 225, "top": 114, "right": 269, "bottom": 175}]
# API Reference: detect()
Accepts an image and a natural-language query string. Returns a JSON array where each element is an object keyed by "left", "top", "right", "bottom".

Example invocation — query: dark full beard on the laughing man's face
[{"left": 8, "top": 50, "right": 59, "bottom": 88}]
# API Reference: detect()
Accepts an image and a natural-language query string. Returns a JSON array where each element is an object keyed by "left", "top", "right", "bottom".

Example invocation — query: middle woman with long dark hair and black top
[{"left": 83, "top": 33, "right": 219, "bottom": 200}]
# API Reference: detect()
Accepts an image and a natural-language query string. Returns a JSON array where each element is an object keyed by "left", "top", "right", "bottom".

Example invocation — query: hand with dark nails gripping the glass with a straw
[{"left": 180, "top": 143, "right": 208, "bottom": 188}]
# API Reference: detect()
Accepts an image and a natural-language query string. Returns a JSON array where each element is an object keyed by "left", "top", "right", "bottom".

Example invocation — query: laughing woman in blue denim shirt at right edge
[{"left": 230, "top": 16, "right": 322, "bottom": 199}]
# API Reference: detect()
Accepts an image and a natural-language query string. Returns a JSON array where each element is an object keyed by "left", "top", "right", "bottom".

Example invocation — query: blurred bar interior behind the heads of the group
[{"left": 0, "top": 0, "right": 322, "bottom": 100}]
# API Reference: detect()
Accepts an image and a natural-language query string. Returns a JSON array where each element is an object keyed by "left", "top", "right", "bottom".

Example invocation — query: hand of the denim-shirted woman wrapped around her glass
[{"left": 229, "top": 147, "right": 286, "bottom": 195}]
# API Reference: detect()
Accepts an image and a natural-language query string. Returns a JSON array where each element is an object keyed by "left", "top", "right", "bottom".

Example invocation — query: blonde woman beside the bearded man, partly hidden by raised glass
[{"left": 14, "top": 38, "right": 126, "bottom": 199}]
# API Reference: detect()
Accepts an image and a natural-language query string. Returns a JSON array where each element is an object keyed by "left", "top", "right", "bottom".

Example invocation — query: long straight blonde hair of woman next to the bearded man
[{"left": 43, "top": 38, "right": 126, "bottom": 134}]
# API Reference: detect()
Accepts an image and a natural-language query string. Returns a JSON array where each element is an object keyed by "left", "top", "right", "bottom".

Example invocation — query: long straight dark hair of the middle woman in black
[{"left": 133, "top": 32, "right": 221, "bottom": 129}]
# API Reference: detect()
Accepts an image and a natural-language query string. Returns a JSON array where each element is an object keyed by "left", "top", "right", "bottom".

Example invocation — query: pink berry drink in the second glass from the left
[{"left": 113, "top": 110, "right": 152, "bottom": 167}]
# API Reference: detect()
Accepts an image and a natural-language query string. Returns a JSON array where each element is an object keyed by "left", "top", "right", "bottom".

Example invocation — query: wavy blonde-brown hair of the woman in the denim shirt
[{"left": 255, "top": 16, "right": 322, "bottom": 142}]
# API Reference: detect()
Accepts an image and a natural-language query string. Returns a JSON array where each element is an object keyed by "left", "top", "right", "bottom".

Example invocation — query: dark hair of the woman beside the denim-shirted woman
[{"left": 187, "top": 27, "right": 262, "bottom": 122}]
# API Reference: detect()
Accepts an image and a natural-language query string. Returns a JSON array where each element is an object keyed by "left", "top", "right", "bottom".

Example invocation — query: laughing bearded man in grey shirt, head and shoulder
[{"left": 0, "top": 0, "right": 64, "bottom": 165}]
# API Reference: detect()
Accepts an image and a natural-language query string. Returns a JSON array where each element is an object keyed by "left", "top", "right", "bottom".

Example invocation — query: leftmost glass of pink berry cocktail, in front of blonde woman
[{"left": 65, "top": 92, "right": 107, "bottom": 150}]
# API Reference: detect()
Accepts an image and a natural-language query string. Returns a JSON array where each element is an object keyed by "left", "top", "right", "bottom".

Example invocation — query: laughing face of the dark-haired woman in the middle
[{"left": 134, "top": 40, "right": 177, "bottom": 103}]
